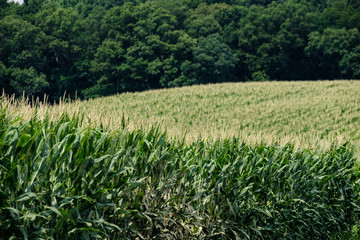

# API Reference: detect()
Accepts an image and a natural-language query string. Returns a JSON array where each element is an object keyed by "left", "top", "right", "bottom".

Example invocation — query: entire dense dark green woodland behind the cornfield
[{"left": 0, "top": 0, "right": 360, "bottom": 98}]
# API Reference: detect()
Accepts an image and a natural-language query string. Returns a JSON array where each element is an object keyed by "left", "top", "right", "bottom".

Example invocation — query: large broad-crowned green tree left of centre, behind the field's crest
[{"left": 86, "top": 3, "right": 195, "bottom": 97}]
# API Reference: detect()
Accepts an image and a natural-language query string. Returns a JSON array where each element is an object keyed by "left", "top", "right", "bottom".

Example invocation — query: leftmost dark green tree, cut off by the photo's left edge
[{"left": 0, "top": 15, "right": 49, "bottom": 95}]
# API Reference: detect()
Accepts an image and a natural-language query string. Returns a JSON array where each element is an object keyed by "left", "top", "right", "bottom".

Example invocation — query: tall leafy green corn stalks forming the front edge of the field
[{"left": 0, "top": 110, "right": 360, "bottom": 239}]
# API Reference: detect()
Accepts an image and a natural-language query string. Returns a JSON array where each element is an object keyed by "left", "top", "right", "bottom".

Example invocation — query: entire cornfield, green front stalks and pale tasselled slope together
[{"left": 0, "top": 81, "right": 360, "bottom": 239}]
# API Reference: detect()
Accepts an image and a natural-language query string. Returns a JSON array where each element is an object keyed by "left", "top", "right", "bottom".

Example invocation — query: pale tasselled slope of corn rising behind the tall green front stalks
[{"left": 3, "top": 80, "right": 360, "bottom": 149}]
